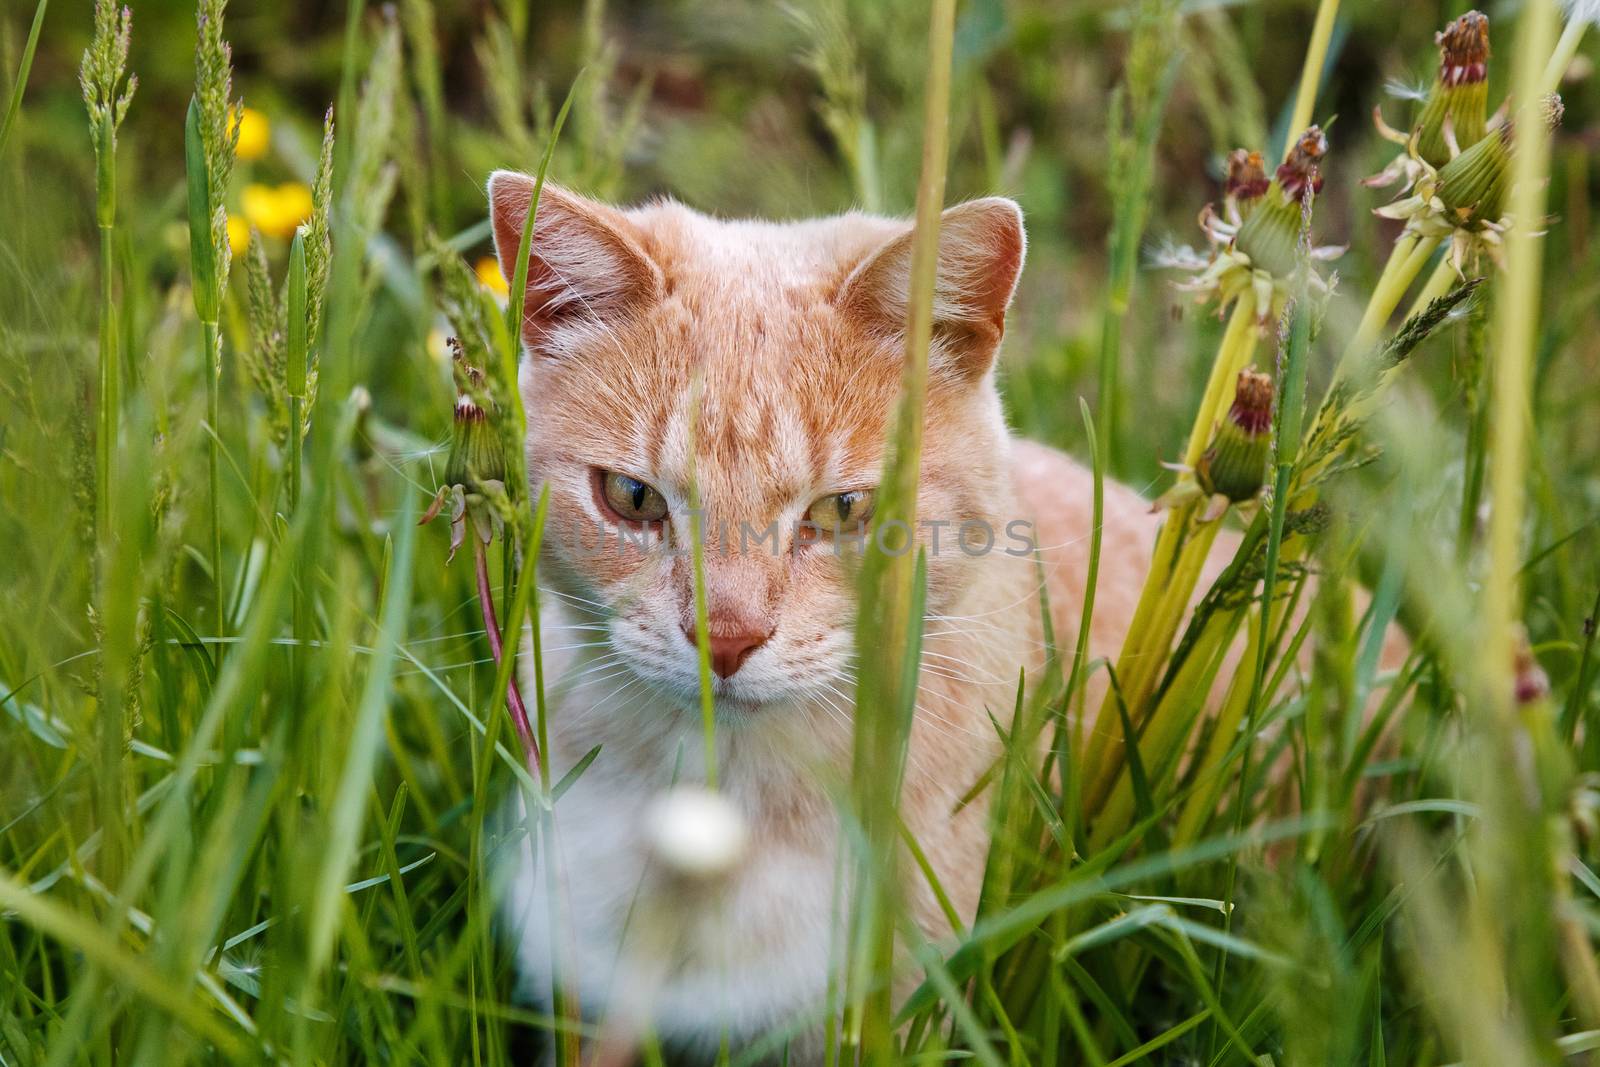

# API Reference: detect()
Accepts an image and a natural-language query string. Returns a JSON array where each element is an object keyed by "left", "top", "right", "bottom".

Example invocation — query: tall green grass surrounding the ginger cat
[{"left": 0, "top": 0, "right": 1600, "bottom": 1067}]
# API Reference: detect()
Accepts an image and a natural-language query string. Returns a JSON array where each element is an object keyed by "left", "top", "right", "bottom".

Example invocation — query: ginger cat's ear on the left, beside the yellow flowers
[{"left": 490, "top": 171, "right": 664, "bottom": 347}]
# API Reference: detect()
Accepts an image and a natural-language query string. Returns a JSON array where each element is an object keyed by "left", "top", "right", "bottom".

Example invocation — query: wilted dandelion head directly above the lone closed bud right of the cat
[{"left": 1162, "top": 126, "right": 1344, "bottom": 328}]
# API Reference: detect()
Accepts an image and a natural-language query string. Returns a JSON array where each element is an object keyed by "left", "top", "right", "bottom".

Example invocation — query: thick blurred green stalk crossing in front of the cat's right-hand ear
[{"left": 845, "top": 0, "right": 955, "bottom": 1064}]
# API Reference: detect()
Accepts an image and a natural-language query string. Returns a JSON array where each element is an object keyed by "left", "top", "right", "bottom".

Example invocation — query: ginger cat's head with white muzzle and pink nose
[{"left": 488, "top": 171, "right": 1024, "bottom": 710}]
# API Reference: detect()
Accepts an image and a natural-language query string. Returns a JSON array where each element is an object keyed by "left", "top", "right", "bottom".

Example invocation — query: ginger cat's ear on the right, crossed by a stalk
[{"left": 837, "top": 197, "right": 1027, "bottom": 381}]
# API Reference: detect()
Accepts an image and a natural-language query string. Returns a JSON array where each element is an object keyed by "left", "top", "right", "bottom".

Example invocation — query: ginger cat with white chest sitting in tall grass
[{"left": 488, "top": 171, "right": 1184, "bottom": 1062}]
